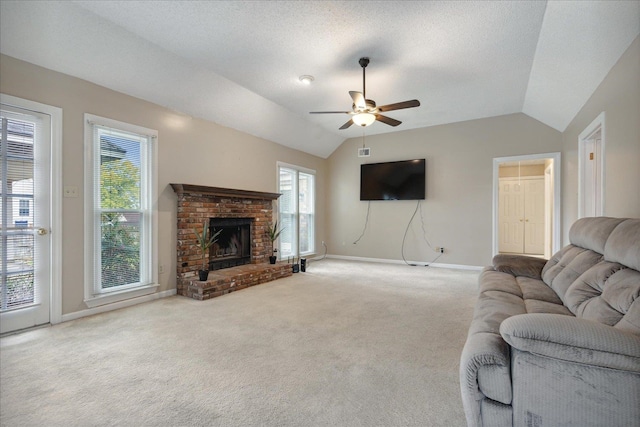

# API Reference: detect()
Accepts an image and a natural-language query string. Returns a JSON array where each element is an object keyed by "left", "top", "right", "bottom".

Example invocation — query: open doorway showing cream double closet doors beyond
[{"left": 493, "top": 153, "right": 561, "bottom": 259}]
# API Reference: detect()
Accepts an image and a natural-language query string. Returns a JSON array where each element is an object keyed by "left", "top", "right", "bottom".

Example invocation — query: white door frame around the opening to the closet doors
[{"left": 492, "top": 152, "right": 562, "bottom": 256}]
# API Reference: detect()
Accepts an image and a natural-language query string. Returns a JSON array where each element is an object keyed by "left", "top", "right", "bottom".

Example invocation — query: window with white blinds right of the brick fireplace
[{"left": 278, "top": 163, "right": 315, "bottom": 259}]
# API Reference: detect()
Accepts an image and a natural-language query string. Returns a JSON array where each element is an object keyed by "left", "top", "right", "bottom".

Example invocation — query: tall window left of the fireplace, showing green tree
[{"left": 85, "top": 114, "right": 157, "bottom": 306}]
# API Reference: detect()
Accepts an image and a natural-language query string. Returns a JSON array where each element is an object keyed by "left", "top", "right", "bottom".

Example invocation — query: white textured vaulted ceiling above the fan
[{"left": 0, "top": 0, "right": 640, "bottom": 157}]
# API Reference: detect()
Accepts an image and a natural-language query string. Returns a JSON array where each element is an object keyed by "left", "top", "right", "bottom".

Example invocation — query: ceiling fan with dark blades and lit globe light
[{"left": 309, "top": 58, "right": 420, "bottom": 129}]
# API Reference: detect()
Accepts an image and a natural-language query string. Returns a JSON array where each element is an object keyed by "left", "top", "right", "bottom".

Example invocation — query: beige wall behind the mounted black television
[{"left": 327, "top": 114, "right": 562, "bottom": 266}]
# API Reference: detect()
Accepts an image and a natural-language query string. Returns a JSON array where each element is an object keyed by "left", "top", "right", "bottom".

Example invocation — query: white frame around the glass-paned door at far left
[{"left": 0, "top": 93, "right": 63, "bottom": 332}]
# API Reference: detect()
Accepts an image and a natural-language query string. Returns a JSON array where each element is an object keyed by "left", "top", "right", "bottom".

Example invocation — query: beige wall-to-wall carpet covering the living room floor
[{"left": 0, "top": 259, "right": 478, "bottom": 427}]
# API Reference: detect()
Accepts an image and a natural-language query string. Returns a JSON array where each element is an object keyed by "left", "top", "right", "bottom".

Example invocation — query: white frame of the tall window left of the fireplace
[{"left": 84, "top": 114, "right": 159, "bottom": 308}]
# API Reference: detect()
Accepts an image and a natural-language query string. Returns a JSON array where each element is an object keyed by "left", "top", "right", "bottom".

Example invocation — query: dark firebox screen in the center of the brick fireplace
[{"left": 209, "top": 218, "right": 252, "bottom": 270}]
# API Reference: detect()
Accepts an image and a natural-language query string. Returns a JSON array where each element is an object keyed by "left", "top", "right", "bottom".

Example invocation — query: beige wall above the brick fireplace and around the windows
[{"left": 0, "top": 56, "right": 326, "bottom": 314}]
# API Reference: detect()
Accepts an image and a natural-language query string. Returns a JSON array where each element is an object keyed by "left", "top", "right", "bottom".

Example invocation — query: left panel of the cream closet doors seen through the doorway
[{"left": 498, "top": 179, "right": 524, "bottom": 253}]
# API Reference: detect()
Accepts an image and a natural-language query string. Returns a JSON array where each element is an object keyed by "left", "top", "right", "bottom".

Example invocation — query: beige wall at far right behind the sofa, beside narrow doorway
[{"left": 562, "top": 37, "right": 640, "bottom": 240}]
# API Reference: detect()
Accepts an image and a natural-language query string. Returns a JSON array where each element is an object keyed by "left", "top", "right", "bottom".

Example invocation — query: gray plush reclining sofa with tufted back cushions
[{"left": 460, "top": 217, "right": 640, "bottom": 427}]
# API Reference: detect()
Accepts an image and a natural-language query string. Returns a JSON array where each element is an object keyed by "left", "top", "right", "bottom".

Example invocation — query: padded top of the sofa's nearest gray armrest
[{"left": 500, "top": 313, "right": 640, "bottom": 373}]
